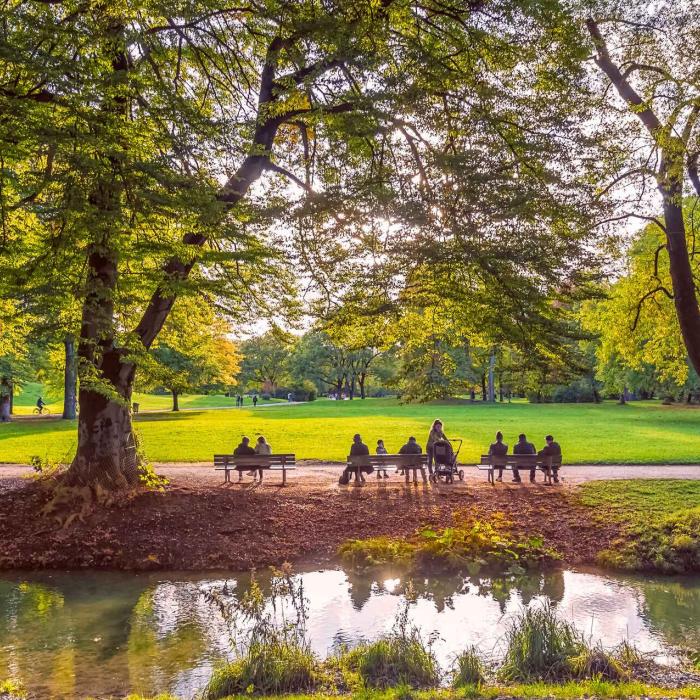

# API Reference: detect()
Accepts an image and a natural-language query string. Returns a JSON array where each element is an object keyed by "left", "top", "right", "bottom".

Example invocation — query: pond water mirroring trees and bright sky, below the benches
[{"left": 0, "top": 569, "right": 700, "bottom": 698}]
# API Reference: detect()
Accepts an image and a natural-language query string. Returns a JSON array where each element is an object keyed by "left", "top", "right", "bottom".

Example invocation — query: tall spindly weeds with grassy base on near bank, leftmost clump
[{"left": 202, "top": 568, "right": 320, "bottom": 700}]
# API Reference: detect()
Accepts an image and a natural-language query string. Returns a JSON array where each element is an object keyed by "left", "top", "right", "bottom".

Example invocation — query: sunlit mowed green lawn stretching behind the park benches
[{"left": 0, "top": 397, "right": 700, "bottom": 464}]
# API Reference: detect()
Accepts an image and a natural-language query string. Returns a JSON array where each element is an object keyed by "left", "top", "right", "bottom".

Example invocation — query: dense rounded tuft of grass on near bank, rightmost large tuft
[{"left": 499, "top": 605, "right": 586, "bottom": 682}]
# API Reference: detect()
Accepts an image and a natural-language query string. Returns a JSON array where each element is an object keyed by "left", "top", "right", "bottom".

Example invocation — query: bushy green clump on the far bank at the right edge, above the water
[{"left": 598, "top": 507, "right": 700, "bottom": 574}]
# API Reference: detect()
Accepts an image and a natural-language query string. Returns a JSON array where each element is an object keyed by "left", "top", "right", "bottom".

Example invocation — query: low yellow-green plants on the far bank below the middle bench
[{"left": 338, "top": 517, "right": 560, "bottom": 571}]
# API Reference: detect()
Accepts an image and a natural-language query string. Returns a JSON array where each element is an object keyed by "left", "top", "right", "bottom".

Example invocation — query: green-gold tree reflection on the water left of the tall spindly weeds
[{"left": 0, "top": 573, "right": 228, "bottom": 698}]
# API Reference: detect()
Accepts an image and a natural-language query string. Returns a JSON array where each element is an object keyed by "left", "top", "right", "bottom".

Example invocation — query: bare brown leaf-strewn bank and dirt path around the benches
[{"left": 0, "top": 463, "right": 700, "bottom": 570}]
